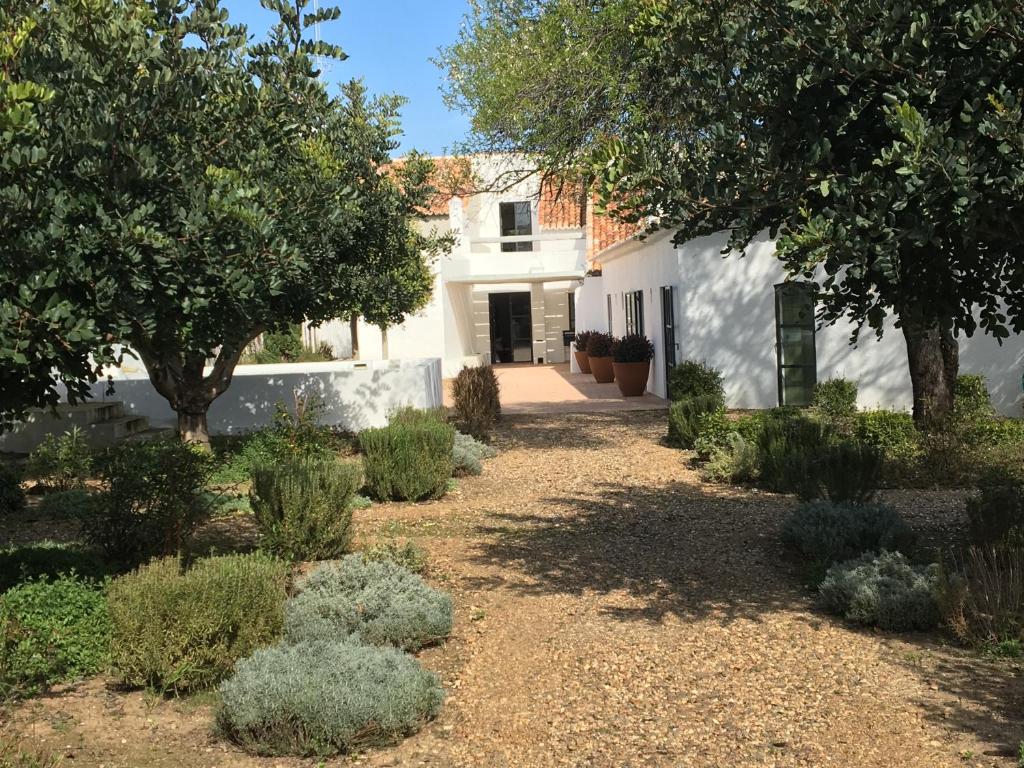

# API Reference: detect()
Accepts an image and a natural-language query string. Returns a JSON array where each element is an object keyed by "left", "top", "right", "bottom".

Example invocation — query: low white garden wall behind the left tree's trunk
[{"left": 93, "top": 358, "right": 442, "bottom": 434}]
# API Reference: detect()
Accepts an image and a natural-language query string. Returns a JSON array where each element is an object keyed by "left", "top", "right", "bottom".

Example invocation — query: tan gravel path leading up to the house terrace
[{"left": 367, "top": 413, "right": 1024, "bottom": 768}]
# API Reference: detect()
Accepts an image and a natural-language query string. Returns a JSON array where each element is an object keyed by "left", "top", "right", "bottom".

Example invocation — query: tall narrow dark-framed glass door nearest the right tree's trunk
[{"left": 775, "top": 283, "right": 818, "bottom": 406}]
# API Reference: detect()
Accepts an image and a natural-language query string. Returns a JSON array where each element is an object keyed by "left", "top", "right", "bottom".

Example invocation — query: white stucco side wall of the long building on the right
[{"left": 577, "top": 232, "right": 1024, "bottom": 415}]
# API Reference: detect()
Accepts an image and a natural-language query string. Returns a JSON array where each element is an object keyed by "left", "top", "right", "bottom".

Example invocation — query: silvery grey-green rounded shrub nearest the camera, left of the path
[{"left": 217, "top": 642, "right": 444, "bottom": 756}]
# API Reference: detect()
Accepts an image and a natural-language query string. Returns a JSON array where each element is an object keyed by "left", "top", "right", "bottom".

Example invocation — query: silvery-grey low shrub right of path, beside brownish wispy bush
[{"left": 818, "top": 552, "right": 939, "bottom": 631}]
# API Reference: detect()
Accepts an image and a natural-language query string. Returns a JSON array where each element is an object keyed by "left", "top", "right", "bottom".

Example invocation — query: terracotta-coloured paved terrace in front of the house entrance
[{"left": 444, "top": 362, "right": 669, "bottom": 415}]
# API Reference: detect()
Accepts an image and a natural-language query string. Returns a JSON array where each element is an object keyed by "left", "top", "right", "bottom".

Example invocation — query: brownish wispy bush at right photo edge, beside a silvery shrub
[{"left": 940, "top": 542, "right": 1024, "bottom": 649}]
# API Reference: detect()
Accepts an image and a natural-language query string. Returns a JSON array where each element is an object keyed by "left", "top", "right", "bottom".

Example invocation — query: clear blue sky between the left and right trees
[{"left": 221, "top": 0, "right": 469, "bottom": 155}]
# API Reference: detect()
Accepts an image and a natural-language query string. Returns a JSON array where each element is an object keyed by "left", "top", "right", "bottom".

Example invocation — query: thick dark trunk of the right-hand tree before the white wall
[{"left": 902, "top": 318, "right": 959, "bottom": 429}]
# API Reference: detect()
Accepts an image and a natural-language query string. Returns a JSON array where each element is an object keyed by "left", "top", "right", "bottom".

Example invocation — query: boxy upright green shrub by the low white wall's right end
[{"left": 359, "top": 421, "right": 455, "bottom": 501}]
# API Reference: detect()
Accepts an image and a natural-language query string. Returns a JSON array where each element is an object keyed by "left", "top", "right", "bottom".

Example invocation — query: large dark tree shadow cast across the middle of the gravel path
[{"left": 470, "top": 483, "right": 807, "bottom": 623}]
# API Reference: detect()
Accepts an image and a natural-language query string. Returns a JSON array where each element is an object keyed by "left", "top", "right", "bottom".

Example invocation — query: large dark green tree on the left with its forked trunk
[{"left": 0, "top": 0, "right": 443, "bottom": 440}]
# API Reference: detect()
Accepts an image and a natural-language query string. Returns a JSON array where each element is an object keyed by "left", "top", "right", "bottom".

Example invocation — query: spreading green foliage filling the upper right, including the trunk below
[{"left": 441, "top": 0, "right": 1024, "bottom": 422}]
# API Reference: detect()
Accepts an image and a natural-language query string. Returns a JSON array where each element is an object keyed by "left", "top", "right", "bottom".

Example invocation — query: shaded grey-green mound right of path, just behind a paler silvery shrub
[{"left": 781, "top": 502, "right": 915, "bottom": 565}]
